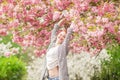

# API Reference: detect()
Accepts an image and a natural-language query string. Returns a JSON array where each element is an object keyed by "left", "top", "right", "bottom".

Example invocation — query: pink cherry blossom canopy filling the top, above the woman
[{"left": 0, "top": 0, "right": 120, "bottom": 56}]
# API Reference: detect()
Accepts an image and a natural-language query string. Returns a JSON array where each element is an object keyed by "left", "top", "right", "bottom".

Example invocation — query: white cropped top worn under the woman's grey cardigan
[{"left": 46, "top": 46, "right": 59, "bottom": 70}]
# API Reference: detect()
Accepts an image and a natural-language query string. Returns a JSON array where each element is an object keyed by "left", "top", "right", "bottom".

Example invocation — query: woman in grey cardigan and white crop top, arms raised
[{"left": 40, "top": 19, "right": 73, "bottom": 80}]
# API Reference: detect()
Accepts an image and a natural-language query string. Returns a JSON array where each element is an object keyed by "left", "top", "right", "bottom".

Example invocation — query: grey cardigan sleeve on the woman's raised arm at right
[{"left": 62, "top": 27, "right": 73, "bottom": 55}]
